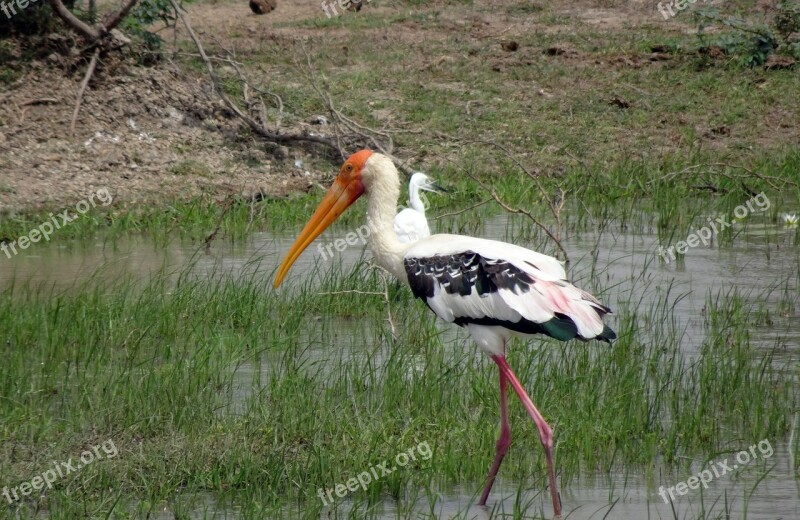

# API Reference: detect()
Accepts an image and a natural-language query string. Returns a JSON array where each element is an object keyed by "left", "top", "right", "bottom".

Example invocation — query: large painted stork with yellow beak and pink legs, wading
[{"left": 274, "top": 150, "right": 616, "bottom": 516}]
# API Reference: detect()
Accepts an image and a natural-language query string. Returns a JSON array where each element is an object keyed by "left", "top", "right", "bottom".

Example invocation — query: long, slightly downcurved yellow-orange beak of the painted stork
[{"left": 273, "top": 175, "right": 364, "bottom": 288}]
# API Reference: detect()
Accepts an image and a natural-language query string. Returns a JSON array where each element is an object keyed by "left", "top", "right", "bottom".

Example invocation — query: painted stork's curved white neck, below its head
[{"left": 367, "top": 166, "right": 409, "bottom": 282}]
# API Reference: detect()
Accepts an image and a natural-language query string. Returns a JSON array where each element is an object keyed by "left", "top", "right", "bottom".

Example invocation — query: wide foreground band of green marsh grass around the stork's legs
[{"left": 0, "top": 249, "right": 800, "bottom": 518}]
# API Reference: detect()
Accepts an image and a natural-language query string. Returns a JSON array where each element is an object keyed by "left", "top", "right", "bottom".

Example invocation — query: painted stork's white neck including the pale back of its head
[{"left": 362, "top": 153, "right": 410, "bottom": 282}]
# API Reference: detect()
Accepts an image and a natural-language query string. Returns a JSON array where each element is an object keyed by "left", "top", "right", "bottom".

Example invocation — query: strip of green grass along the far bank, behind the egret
[{"left": 0, "top": 146, "right": 800, "bottom": 256}]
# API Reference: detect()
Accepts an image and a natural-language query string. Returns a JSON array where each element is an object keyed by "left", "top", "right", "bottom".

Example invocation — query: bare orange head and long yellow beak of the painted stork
[{"left": 274, "top": 150, "right": 372, "bottom": 287}]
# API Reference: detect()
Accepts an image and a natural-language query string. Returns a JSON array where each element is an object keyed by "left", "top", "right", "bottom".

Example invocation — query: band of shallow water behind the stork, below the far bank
[{"left": 0, "top": 215, "right": 800, "bottom": 360}]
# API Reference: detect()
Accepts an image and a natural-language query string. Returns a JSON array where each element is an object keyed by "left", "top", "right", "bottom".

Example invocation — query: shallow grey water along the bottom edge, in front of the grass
[{"left": 144, "top": 458, "right": 800, "bottom": 520}]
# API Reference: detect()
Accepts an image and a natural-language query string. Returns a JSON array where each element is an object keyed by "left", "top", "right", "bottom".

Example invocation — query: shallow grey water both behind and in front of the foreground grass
[{"left": 0, "top": 210, "right": 800, "bottom": 520}]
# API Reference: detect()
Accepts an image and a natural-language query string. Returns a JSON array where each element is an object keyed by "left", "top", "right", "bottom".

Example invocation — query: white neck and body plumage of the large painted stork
[{"left": 362, "top": 154, "right": 608, "bottom": 356}]
